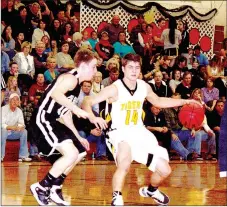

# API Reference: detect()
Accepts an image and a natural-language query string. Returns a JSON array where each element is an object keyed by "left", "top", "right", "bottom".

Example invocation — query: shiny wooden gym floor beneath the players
[{"left": 1, "top": 160, "right": 227, "bottom": 206}]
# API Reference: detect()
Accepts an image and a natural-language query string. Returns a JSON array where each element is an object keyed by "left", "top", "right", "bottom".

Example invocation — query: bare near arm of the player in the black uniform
[{"left": 51, "top": 74, "right": 88, "bottom": 118}]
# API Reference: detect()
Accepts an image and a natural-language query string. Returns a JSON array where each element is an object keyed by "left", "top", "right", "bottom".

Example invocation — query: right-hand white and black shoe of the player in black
[{"left": 50, "top": 185, "right": 70, "bottom": 206}]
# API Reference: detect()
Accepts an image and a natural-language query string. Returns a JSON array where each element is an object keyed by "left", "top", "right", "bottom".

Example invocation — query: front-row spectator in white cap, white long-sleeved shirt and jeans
[{"left": 1, "top": 93, "right": 31, "bottom": 162}]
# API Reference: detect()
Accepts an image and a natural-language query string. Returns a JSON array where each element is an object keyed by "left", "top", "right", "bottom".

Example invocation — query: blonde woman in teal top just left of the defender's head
[{"left": 44, "top": 56, "right": 60, "bottom": 84}]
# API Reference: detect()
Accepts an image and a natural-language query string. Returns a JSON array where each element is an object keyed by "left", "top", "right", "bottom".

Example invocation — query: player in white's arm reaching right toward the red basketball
[{"left": 146, "top": 84, "right": 202, "bottom": 108}]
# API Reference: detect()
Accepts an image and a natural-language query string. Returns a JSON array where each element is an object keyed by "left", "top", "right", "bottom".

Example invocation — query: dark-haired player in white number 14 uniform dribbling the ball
[{"left": 82, "top": 54, "right": 200, "bottom": 206}]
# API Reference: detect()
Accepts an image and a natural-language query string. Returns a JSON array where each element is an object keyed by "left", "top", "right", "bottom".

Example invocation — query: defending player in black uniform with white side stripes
[{"left": 30, "top": 49, "right": 97, "bottom": 205}]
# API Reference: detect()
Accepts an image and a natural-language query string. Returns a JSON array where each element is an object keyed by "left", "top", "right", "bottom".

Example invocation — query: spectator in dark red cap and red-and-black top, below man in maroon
[{"left": 95, "top": 31, "right": 114, "bottom": 61}]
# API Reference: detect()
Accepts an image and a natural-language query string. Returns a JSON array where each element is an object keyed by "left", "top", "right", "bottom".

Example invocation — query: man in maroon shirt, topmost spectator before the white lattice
[{"left": 100, "top": 15, "right": 125, "bottom": 45}]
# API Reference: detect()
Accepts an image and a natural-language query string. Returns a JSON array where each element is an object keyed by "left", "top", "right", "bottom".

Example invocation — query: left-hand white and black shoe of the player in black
[{"left": 30, "top": 183, "right": 50, "bottom": 206}]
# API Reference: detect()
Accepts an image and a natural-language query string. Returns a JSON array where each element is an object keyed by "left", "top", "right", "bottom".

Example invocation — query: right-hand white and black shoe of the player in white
[{"left": 139, "top": 187, "right": 169, "bottom": 206}]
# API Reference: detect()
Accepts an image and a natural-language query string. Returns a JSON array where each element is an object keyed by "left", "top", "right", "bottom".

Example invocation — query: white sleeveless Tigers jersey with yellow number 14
[{"left": 111, "top": 80, "right": 147, "bottom": 129}]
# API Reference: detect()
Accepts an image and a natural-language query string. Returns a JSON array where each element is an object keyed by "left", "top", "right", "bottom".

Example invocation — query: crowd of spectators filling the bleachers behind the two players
[{"left": 1, "top": 0, "right": 227, "bottom": 161}]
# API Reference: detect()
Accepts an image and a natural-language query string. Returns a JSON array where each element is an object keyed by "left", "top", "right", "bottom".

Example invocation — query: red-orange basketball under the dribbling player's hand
[{"left": 178, "top": 103, "right": 204, "bottom": 129}]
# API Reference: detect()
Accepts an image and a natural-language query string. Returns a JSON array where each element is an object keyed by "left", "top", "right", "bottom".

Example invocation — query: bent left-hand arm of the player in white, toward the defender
[{"left": 81, "top": 84, "right": 118, "bottom": 129}]
